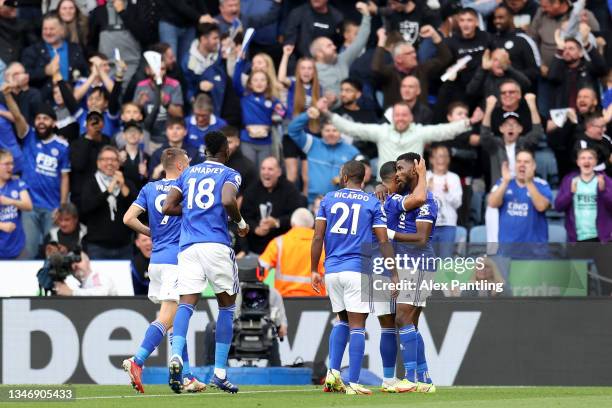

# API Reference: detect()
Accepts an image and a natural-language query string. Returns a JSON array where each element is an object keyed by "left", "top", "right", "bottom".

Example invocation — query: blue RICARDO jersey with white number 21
[{"left": 317, "top": 188, "right": 387, "bottom": 273}]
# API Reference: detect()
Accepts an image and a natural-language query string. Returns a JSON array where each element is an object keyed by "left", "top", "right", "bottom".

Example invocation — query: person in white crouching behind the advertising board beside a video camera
[{"left": 54, "top": 252, "right": 117, "bottom": 296}]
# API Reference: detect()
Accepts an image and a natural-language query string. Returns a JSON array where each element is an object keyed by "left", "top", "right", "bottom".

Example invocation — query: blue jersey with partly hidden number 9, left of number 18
[{"left": 133, "top": 179, "right": 181, "bottom": 265}]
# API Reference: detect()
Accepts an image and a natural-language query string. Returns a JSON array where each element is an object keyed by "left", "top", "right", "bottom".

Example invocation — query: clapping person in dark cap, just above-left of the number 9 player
[{"left": 119, "top": 120, "right": 149, "bottom": 190}]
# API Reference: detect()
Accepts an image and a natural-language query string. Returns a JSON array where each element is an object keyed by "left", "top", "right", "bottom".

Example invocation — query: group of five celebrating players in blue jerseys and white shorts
[{"left": 117, "top": 131, "right": 437, "bottom": 395}]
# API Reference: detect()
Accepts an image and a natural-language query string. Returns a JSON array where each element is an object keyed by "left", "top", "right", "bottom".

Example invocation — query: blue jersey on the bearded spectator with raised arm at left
[{"left": 23, "top": 127, "right": 70, "bottom": 210}]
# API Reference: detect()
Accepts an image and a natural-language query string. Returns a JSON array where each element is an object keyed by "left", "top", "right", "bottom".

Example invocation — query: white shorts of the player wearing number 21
[{"left": 325, "top": 272, "right": 374, "bottom": 313}]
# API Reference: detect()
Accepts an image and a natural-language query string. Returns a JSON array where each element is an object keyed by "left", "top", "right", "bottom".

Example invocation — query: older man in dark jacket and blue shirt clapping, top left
[{"left": 21, "top": 13, "right": 89, "bottom": 100}]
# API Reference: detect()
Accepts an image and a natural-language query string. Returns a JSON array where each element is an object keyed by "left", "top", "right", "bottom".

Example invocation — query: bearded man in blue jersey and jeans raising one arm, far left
[{"left": 2, "top": 84, "right": 70, "bottom": 259}]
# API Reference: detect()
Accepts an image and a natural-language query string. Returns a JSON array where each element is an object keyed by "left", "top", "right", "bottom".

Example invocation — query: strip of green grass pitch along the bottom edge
[{"left": 0, "top": 385, "right": 612, "bottom": 408}]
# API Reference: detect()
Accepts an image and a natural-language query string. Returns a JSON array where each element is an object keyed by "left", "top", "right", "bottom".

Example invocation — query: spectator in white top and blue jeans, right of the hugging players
[{"left": 427, "top": 144, "right": 463, "bottom": 257}]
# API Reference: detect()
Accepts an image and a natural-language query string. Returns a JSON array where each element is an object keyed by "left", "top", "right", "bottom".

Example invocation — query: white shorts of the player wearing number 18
[{"left": 178, "top": 242, "right": 240, "bottom": 295}]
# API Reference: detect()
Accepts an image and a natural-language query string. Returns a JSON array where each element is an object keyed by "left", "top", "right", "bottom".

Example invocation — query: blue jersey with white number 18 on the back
[{"left": 173, "top": 161, "right": 242, "bottom": 251}]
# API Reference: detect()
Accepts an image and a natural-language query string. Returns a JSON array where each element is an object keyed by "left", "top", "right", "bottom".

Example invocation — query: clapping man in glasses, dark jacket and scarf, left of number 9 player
[{"left": 81, "top": 146, "right": 138, "bottom": 259}]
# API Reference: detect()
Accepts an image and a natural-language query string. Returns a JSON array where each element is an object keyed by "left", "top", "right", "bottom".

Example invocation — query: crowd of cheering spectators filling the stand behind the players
[{"left": 0, "top": 0, "right": 612, "bottom": 296}]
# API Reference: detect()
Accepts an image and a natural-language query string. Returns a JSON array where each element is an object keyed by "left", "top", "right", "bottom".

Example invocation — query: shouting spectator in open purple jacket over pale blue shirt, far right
[{"left": 555, "top": 148, "right": 612, "bottom": 242}]
